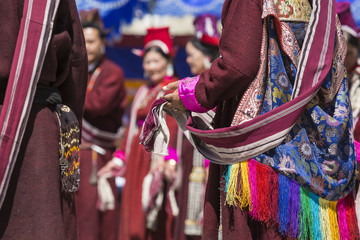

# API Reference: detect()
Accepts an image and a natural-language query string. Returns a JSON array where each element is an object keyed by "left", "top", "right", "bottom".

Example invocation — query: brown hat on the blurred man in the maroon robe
[{"left": 80, "top": 8, "right": 109, "bottom": 37}]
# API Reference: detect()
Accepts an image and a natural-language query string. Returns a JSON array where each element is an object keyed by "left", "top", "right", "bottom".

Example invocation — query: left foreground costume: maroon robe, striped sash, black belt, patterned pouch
[{"left": 0, "top": 0, "right": 87, "bottom": 240}]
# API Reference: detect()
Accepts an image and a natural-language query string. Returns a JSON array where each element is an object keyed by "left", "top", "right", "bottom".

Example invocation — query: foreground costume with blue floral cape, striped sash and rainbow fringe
[{"left": 142, "top": 0, "right": 359, "bottom": 239}]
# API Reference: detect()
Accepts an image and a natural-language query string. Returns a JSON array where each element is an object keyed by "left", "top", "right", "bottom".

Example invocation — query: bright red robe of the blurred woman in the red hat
[{"left": 119, "top": 79, "right": 177, "bottom": 240}]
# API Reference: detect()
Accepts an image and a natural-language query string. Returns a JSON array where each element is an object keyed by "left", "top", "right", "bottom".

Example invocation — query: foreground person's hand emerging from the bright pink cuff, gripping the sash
[{"left": 163, "top": 81, "right": 186, "bottom": 112}]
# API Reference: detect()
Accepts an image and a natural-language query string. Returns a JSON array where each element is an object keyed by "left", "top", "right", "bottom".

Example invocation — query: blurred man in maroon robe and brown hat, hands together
[{"left": 76, "top": 9, "right": 126, "bottom": 240}]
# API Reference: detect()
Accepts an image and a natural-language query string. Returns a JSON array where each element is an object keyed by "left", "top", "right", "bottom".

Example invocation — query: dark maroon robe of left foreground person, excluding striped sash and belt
[{"left": 0, "top": 0, "right": 87, "bottom": 240}]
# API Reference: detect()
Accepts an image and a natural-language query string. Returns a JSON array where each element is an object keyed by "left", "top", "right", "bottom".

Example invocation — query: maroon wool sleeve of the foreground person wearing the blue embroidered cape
[{"left": 195, "top": 0, "right": 262, "bottom": 109}]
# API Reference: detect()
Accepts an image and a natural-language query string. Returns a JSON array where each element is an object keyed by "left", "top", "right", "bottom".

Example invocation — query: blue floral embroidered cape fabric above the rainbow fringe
[{"left": 255, "top": 18, "right": 356, "bottom": 201}]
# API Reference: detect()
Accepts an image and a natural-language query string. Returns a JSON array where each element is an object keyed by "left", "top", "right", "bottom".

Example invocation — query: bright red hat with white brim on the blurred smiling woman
[{"left": 132, "top": 27, "right": 175, "bottom": 56}]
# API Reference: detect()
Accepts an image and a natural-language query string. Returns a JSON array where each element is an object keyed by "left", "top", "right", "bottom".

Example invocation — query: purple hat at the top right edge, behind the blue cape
[{"left": 336, "top": 2, "right": 359, "bottom": 38}]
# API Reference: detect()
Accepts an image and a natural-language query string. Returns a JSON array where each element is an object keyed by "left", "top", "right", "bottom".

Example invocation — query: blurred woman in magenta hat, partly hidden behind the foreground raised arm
[{"left": 175, "top": 14, "right": 220, "bottom": 240}]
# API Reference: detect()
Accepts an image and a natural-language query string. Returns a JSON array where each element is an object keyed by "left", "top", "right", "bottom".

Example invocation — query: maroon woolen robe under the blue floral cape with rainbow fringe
[{"left": 195, "top": 0, "right": 281, "bottom": 240}]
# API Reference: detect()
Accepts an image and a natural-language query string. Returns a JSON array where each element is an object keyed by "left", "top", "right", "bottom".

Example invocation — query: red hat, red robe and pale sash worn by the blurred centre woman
[{"left": 119, "top": 28, "right": 178, "bottom": 240}]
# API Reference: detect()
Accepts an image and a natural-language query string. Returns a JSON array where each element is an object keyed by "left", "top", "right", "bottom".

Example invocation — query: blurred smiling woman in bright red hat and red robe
[{"left": 99, "top": 27, "right": 179, "bottom": 240}]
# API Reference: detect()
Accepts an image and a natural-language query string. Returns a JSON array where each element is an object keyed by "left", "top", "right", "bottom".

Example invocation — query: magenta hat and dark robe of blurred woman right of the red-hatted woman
[{"left": 175, "top": 14, "right": 220, "bottom": 240}]
